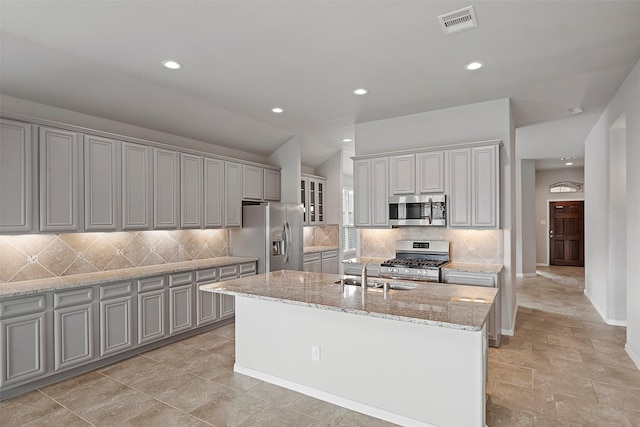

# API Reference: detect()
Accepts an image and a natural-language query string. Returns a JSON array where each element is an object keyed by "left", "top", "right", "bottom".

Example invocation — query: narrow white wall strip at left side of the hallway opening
[{"left": 516, "top": 159, "right": 536, "bottom": 277}]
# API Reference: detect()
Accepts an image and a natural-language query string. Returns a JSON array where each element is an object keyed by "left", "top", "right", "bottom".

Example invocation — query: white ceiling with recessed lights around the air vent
[{"left": 0, "top": 0, "right": 640, "bottom": 167}]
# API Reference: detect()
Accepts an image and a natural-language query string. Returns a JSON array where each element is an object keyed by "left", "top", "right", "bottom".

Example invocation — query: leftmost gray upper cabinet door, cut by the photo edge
[{"left": 0, "top": 119, "right": 35, "bottom": 233}]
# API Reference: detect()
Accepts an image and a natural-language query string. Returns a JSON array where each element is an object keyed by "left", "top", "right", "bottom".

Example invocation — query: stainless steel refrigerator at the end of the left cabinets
[{"left": 229, "top": 202, "right": 303, "bottom": 273}]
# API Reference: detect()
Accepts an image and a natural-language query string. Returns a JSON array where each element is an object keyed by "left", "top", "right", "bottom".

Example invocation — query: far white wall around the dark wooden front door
[{"left": 534, "top": 167, "right": 591, "bottom": 265}]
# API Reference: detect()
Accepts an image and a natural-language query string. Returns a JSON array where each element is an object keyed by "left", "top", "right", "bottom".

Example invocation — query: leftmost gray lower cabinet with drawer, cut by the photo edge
[{"left": 0, "top": 295, "right": 50, "bottom": 388}]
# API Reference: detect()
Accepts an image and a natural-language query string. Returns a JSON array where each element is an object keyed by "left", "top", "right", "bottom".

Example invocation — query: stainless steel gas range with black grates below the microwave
[{"left": 380, "top": 240, "right": 450, "bottom": 282}]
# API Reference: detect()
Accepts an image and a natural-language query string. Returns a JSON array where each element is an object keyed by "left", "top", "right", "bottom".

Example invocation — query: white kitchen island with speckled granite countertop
[{"left": 200, "top": 271, "right": 497, "bottom": 426}]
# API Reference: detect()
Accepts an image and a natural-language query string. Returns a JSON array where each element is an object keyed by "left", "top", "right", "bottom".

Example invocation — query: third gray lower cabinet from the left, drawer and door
[{"left": 99, "top": 282, "right": 135, "bottom": 357}]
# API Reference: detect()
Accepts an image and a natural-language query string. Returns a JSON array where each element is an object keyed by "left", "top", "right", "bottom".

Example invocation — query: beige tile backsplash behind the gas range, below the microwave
[{"left": 360, "top": 227, "right": 503, "bottom": 264}]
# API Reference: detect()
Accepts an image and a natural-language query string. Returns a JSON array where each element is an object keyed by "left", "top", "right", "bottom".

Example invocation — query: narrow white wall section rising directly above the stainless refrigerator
[{"left": 267, "top": 136, "right": 302, "bottom": 203}]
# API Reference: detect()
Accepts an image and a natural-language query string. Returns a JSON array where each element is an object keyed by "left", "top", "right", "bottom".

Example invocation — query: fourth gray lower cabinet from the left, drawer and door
[{"left": 138, "top": 276, "right": 167, "bottom": 344}]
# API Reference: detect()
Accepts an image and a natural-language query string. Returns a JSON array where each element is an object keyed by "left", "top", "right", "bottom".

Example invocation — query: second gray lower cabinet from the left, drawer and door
[{"left": 53, "top": 288, "right": 95, "bottom": 371}]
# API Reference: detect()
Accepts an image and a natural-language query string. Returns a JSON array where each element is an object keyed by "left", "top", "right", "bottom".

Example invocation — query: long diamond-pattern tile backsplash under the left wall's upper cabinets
[{"left": 0, "top": 230, "right": 229, "bottom": 283}]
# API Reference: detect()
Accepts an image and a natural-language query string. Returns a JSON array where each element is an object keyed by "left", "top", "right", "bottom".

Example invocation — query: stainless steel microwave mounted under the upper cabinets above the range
[{"left": 389, "top": 194, "right": 447, "bottom": 227}]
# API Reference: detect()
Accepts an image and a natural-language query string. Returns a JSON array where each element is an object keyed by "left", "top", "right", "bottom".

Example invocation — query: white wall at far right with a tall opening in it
[{"left": 584, "top": 56, "right": 640, "bottom": 366}]
